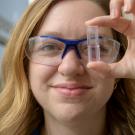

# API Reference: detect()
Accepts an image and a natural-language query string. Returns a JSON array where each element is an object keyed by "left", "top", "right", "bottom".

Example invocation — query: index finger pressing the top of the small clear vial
[{"left": 85, "top": 16, "right": 133, "bottom": 36}]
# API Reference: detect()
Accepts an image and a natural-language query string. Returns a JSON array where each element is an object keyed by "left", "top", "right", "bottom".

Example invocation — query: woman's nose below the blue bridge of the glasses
[{"left": 58, "top": 49, "right": 85, "bottom": 76}]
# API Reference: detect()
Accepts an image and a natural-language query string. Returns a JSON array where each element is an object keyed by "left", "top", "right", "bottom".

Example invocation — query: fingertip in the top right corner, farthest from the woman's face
[{"left": 124, "top": 0, "right": 135, "bottom": 14}]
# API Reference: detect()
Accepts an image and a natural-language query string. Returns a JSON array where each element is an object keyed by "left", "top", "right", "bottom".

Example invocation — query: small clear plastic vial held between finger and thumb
[{"left": 87, "top": 26, "right": 100, "bottom": 62}]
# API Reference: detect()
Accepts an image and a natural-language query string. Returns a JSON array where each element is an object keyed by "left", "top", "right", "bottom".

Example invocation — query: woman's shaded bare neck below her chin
[{"left": 42, "top": 109, "right": 106, "bottom": 135}]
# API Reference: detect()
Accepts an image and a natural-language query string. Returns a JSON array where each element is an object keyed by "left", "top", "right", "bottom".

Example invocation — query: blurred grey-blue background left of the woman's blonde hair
[{"left": 0, "top": 0, "right": 32, "bottom": 86}]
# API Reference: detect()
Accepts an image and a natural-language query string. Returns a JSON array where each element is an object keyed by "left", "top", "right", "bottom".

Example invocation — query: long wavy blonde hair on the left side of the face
[{"left": 0, "top": 0, "right": 53, "bottom": 135}]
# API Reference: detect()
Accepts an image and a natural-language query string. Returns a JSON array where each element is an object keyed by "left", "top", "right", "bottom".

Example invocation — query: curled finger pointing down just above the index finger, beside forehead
[{"left": 110, "top": 0, "right": 124, "bottom": 18}]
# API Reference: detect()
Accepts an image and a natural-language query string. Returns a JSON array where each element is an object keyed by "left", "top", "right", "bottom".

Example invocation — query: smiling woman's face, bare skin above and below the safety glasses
[{"left": 29, "top": 0, "right": 114, "bottom": 120}]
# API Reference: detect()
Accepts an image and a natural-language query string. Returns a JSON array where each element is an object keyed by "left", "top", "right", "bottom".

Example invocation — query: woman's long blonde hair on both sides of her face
[{"left": 0, "top": 0, "right": 135, "bottom": 135}]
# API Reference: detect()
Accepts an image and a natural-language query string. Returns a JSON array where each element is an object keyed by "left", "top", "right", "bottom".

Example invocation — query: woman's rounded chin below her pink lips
[{"left": 46, "top": 104, "right": 94, "bottom": 124}]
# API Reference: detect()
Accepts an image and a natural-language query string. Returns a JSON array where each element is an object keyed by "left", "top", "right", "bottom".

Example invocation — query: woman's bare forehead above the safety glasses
[{"left": 38, "top": 0, "right": 111, "bottom": 39}]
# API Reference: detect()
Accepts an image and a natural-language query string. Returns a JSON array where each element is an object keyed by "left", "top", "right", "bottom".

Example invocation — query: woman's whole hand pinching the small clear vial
[{"left": 86, "top": 0, "right": 135, "bottom": 78}]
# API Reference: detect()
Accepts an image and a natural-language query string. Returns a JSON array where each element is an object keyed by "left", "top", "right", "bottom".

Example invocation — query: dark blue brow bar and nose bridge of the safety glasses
[{"left": 39, "top": 35, "right": 87, "bottom": 59}]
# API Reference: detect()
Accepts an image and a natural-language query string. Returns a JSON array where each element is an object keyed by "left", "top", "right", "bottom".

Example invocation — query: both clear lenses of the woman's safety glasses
[{"left": 26, "top": 37, "right": 118, "bottom": 66}]
